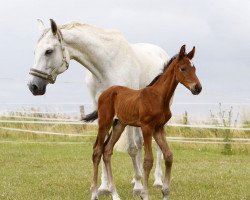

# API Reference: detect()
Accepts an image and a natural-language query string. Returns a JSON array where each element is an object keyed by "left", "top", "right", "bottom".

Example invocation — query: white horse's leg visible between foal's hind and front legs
[{"left": 126, "top": 127, "right": 143, "bottom": 195}]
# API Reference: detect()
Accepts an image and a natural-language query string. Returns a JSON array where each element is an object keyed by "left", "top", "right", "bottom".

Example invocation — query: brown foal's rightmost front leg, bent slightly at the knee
[{"left": 154, "top": 128, "right": 173, "bottom": 200}]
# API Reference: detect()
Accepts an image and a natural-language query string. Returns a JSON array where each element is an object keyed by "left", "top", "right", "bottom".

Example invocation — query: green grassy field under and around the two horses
[{"left": 0, "top": 124, "right": 250, "bottom": 200}]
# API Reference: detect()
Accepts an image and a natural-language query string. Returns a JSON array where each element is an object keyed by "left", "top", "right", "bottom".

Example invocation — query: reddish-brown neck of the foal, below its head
[{"left": 152, "top": 64, "right": 178, "bottom": 106}]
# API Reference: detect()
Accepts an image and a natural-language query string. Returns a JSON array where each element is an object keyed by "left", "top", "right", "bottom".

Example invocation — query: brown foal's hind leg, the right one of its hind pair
[{"left": 103, "top": 120, "right": 125, "bottom": 200}]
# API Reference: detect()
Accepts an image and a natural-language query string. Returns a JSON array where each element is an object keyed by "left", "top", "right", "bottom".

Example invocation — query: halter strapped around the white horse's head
[{"left": 29, "top": 34, "right": 69, "bottom": 84}]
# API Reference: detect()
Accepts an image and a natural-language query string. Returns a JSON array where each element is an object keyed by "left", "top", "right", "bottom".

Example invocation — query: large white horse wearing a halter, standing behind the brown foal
[{"left": 28, "top": 20, "right": 169, "bottom": 199}]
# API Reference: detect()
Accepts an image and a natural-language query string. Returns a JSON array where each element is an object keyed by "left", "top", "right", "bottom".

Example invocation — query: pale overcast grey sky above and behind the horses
[{"left": 0, "top": 0, "right": 250, "bottom": 116}]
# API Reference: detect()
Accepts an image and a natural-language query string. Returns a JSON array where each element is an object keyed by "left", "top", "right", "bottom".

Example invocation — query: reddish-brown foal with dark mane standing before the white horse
[{"left": 89, "top": 45, "right": 202, "bottom": 200}]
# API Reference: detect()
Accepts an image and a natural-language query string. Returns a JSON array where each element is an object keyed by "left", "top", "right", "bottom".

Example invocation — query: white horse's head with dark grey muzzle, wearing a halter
[{"left": 28, "top": 19, "right": 69, "bottom": 95}]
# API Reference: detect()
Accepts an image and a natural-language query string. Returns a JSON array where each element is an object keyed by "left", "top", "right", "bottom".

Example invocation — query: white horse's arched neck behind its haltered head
[{"left": 61, "top": 25, "right": 121, "bottom": 80}]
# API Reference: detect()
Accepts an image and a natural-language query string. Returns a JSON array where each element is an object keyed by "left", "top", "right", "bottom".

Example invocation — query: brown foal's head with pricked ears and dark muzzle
[{"left": 175, "top": 45, "right": 202, "bottom": 95}]
